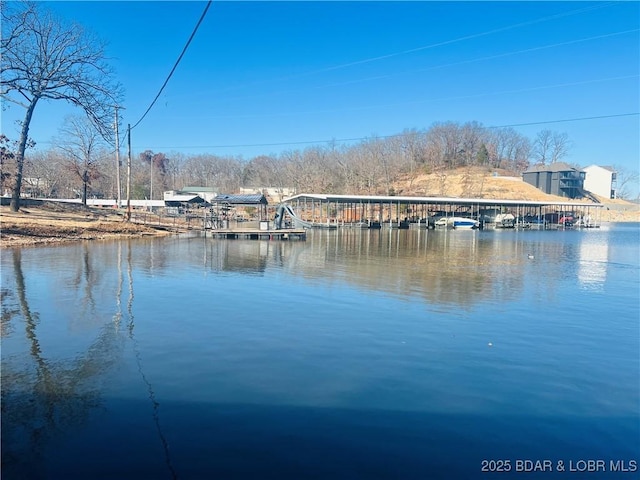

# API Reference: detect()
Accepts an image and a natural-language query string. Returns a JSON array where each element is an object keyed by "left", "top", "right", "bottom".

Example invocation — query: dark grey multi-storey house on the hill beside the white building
[{"left": 522, "top": 163, "right": 586, "bottom": 198}]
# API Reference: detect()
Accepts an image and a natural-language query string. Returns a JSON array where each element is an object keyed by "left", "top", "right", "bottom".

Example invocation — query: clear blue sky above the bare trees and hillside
[{"left": 2, "top": 1, "right": 640, "bottom": 177}]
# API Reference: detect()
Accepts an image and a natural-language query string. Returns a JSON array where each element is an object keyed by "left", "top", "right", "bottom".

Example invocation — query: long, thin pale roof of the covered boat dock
[{"left": 283, "top": 193, "right": 603, "bottom": 208}]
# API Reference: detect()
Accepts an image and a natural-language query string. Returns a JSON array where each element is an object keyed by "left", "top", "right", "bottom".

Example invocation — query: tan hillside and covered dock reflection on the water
[{"left": 291, "top": 230, "right": 526, "bottom": 307}]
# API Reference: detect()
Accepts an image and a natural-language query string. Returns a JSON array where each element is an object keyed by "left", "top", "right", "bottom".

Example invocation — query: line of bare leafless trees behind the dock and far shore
[{"left": 0, "top": 122, "right": 592, "bottom": 203}]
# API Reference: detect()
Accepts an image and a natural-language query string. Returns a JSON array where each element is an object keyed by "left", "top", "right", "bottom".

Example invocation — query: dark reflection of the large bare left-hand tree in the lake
[{"left": 2, "top": 249, "right": 126, "bottom": 478}]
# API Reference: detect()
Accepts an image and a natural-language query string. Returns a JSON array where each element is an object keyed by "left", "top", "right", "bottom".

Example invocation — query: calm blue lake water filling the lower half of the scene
[{"left": 1, "top": 224, "right": 640, "bottom": 479}]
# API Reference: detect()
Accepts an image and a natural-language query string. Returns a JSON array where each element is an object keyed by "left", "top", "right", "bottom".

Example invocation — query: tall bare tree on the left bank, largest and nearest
[{"left": 0, "top": 1, "right": 121, "bottom": 211}]
